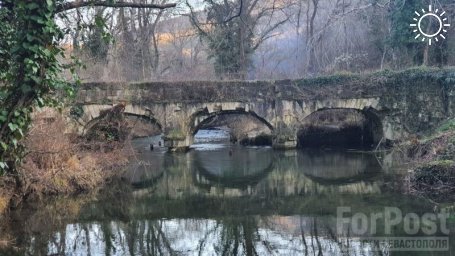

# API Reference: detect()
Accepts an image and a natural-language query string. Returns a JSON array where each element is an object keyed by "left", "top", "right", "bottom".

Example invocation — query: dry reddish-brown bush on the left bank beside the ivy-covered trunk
[{"left": 21, "top": 110, "right": 132, "bottom": 195}]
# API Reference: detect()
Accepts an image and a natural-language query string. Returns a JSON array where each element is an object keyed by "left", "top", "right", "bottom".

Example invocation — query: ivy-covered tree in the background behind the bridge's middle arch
[{"left": 186, "top": 0, "right": 288, "bottom": 79}]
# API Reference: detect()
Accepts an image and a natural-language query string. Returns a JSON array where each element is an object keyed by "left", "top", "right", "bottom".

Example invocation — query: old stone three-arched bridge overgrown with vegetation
[{"left": 74, "top": 69, "right": 455, "bottom": 150}]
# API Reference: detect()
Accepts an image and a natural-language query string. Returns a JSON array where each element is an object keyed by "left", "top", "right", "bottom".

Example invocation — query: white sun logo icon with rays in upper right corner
[{"left": 410, "top": 5, "right": 450, "bottom": 45}]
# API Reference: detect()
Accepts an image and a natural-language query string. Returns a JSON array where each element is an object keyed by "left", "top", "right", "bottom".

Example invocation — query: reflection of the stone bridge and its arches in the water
[{"left": 130, "top": 131, "right": 382, "bottom": 198}]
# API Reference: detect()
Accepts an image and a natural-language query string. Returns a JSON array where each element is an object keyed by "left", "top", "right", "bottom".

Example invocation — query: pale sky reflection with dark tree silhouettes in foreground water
[{"left": 35, "top": 216, "right": 385, "bottom": 255}]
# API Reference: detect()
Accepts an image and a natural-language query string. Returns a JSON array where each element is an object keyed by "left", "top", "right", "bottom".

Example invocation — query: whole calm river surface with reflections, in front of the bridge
[{"left": 2, "top": 130, "right": 455, "bottom": 255}]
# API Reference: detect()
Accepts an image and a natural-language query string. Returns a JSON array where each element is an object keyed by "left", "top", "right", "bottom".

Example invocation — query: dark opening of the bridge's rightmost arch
[{"left": 297, "top": 107, "right": 384, "bottom": 149}]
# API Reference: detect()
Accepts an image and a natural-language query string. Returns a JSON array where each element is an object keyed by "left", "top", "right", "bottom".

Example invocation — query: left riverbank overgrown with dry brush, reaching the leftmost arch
[{"left": 0, "top": 109, "right": 133, "bottom": 216}]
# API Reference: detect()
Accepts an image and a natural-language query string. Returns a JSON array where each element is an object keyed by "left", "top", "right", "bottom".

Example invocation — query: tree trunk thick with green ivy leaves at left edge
[{"left": 0, "top": 0, "right": 63, "bottom": 180}]
